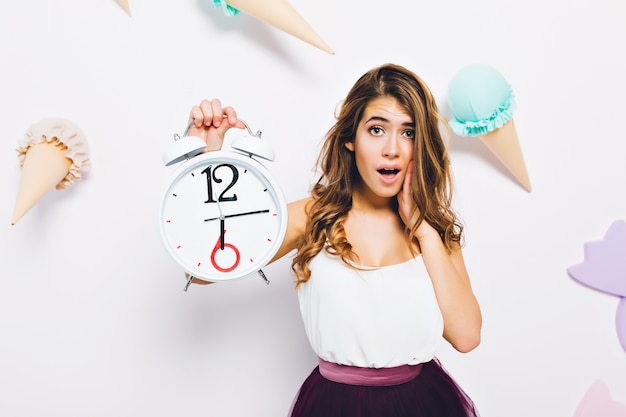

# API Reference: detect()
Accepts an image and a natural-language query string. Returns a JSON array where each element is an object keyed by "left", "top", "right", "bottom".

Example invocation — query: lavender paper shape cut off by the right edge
[{"left": 567, "top": 220, "right": 626, "bottom": 350}]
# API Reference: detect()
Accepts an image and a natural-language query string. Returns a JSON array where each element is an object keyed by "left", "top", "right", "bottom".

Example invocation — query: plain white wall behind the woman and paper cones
[{"left": 0, "top": 0, "right": 626, "bottom": 417}]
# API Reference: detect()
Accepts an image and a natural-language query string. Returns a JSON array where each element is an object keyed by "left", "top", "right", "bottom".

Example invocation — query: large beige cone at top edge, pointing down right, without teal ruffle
[{"left": 226, "top": 0, "right": 335, "bottom": 55}]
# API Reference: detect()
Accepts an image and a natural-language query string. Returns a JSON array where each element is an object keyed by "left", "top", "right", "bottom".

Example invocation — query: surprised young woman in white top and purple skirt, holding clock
[{"left": 184, "top": 64, "right": 482, "bottom": 417}]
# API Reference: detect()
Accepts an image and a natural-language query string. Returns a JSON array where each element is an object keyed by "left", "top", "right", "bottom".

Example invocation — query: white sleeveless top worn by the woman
[{"left": 298, "top": 250, "right": 443, "bottom": 368}]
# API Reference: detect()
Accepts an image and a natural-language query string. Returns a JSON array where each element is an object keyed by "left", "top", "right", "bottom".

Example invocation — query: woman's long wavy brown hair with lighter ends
[{"left": 291, "top": 64, "right": 463, "bottom": 285}]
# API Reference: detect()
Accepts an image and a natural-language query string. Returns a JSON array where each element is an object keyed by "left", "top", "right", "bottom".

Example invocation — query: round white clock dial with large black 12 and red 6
[{"left": 160, "top": 151, "right": 287, "bottom": 281}]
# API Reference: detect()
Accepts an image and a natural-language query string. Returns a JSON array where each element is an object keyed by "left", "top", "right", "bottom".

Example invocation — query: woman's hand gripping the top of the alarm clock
[{"left": 187, "top": 99, "right": 246, "bottom": 151}]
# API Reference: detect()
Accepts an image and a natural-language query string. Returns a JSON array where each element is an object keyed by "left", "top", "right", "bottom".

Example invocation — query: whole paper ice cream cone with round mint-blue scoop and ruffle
[{"left": 448, "top": 64, "right": 532, "bottom": 192}]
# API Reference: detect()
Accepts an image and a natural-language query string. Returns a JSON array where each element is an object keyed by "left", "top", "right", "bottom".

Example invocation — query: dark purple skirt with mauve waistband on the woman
[{"left": 289, "top": 359, "right": 478, "bottom": 417}]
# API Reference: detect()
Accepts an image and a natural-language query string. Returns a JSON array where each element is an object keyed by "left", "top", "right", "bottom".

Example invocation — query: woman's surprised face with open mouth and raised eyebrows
[{"left": 346, "top": 97, "right": 415, "bottom": 203}]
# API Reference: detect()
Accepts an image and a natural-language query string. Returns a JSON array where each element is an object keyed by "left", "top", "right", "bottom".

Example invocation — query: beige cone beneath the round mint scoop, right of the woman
[{"left": 478, "top": 119, "right": 532, "bottom": 192}]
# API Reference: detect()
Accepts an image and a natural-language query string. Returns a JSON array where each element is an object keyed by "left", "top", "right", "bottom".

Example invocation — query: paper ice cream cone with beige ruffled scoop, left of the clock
[{"left": 11, "top": 118, "right": 89, "bottom": 225}]
